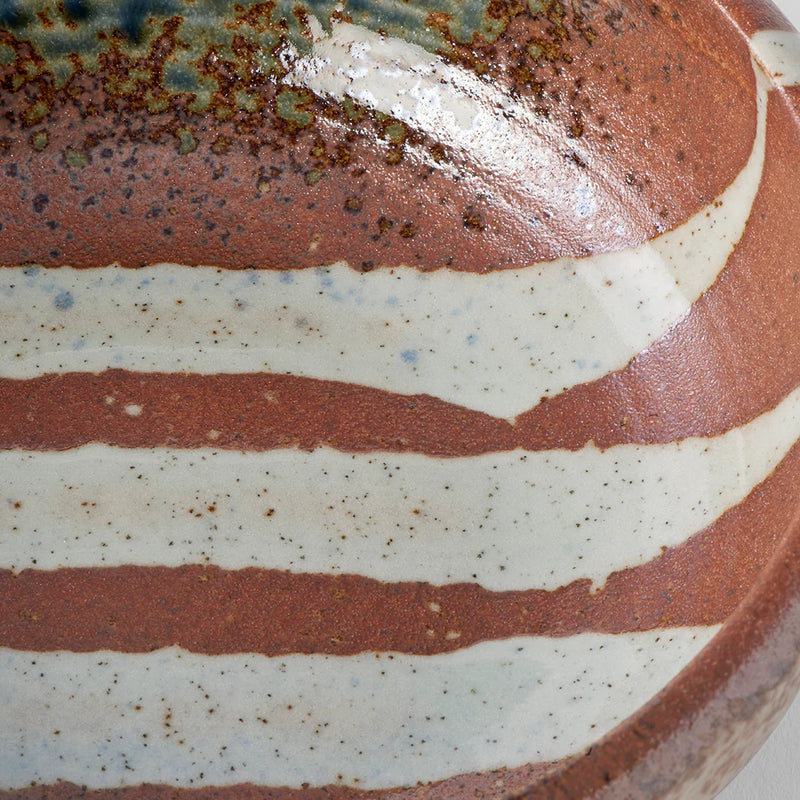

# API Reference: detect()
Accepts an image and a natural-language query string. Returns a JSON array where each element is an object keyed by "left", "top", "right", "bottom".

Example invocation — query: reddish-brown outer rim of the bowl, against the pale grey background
[{"left": 512, "top": 0, "right": 800, "bottom": 800}]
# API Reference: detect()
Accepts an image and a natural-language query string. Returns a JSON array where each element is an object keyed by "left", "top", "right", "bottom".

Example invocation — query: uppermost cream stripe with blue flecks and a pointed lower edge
[{"left": 0, "top": 57, "right": 766, "bottom": 418}]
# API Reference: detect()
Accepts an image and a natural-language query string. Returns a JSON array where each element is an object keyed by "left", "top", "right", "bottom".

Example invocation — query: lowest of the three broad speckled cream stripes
[{"left": 0, "top": 628, "right": 717, "bottom": 789}]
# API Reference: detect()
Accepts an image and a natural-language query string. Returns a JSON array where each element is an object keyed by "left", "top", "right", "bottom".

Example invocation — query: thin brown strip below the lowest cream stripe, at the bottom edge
[{"left": 0, "top": 762, "right": 562, "bottom": 800}]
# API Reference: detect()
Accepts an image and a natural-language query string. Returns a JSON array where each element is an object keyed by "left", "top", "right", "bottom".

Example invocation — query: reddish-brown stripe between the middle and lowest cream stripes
[{"left": 0, "top": 444, "right": 800, "bottom": 655}]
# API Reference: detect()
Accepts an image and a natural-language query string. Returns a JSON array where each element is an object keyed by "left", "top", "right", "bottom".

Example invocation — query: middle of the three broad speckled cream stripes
[{"left": 6, "top": 390, "right": 800, "bottom": 591}]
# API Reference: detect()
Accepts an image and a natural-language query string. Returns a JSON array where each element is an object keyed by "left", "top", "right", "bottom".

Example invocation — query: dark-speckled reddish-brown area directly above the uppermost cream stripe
[{"left": 0, "top": 0, "right": 756, "bottom": 271}]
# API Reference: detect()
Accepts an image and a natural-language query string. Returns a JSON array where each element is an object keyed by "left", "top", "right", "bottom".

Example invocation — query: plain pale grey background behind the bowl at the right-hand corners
[{"left": 712, "top": 0, "right": 800, "bottom": 800}]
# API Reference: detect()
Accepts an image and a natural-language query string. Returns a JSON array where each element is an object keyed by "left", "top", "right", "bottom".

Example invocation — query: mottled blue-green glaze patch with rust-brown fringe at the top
[{"left": 0, "top": 0, "right": 579, "bottom": 134}]
